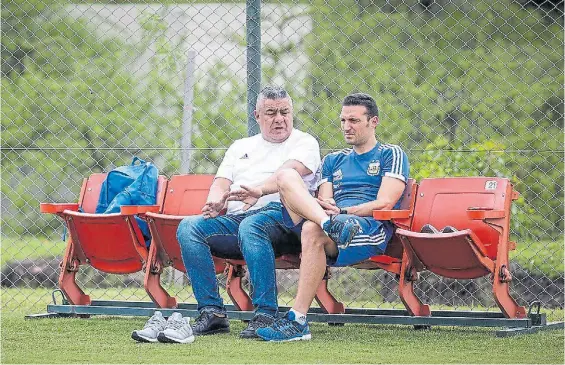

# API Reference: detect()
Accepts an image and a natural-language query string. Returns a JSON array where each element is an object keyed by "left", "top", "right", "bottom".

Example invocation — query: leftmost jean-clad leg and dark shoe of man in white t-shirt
[{"left": 177, "top": 215, "right": 242, "bottom": 335}]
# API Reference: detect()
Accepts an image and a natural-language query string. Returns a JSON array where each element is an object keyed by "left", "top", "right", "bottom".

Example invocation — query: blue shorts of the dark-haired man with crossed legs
[{"left": 282, "top": 206, "right": 394, "bottom": 266}]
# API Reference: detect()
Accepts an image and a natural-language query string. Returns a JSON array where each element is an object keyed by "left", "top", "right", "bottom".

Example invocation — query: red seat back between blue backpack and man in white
[{"left": 163, "top": 175, "right": 214, "bottom": 216}]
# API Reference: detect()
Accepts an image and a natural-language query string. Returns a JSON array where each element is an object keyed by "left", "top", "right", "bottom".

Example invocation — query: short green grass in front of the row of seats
[{"left": 0, "top": 289, "right": 564, "bottom": 364}]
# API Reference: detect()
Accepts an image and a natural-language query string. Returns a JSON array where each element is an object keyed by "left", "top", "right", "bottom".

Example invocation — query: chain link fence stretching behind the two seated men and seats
[{"left": 1, "top": 0, "right": 564, "bottom": 311}]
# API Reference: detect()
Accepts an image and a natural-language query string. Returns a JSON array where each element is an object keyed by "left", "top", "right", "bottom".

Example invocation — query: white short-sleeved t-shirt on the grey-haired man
[{"left": 216, "top": 129, "right": 320, "bottom": 214}]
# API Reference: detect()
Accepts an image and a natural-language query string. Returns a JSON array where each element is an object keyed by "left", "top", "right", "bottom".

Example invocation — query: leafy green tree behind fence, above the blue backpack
[{"left": 2, "top": 1, "right": 176, "bottom": 233}]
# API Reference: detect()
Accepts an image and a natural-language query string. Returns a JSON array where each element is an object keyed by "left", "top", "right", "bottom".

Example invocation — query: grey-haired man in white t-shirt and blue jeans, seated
[{"left": 177, "top": 87, "right": 320, "bottom": 338}]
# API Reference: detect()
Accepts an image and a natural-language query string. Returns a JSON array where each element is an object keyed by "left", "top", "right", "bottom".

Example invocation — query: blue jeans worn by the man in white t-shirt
[{"left": 177, "top": 203, "right": 300, "bottom": 316}]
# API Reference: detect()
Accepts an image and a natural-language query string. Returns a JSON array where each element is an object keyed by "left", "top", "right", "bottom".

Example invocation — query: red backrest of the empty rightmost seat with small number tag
[{"left": 411, "top": 177, "right": 512, "bottom": 259}]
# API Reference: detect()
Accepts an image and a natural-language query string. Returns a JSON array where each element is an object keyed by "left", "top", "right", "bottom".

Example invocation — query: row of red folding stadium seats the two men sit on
[{"left": 40, "top": 174, "right": 526, "bottom": 318}]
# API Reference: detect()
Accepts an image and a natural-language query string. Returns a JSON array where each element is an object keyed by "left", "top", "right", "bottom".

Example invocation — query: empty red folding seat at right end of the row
[{"left": 396, "top": 177, "right": 527, "bottom": 318}]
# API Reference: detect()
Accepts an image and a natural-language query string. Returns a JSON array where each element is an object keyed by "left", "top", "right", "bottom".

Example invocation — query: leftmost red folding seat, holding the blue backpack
[{"left": 40, "top": 173, "right": 167, "bottom": 305}]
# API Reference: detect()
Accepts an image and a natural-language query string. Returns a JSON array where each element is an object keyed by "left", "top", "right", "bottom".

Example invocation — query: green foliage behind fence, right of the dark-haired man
[{"left": 301, "top": 0, "right": 563, "bottom": 237}]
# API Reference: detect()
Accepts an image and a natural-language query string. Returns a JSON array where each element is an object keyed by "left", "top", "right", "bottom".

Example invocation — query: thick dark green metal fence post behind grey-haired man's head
[{"left": 246, "top": 0, "right": 261, "bottom": 136}]
